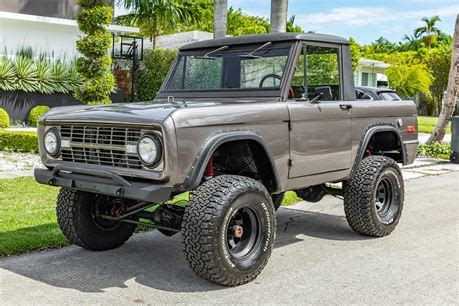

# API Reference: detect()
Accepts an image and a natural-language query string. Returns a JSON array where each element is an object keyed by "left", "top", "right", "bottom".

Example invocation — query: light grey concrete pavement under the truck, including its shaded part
[{"left": 0, "top": 171, "right": 459, "bottom": 305}]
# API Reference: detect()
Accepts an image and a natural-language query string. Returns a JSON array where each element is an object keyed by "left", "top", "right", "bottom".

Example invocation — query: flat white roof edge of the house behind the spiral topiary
[{"left": 0, "top": 11, "right": 140, "bottom": 33}]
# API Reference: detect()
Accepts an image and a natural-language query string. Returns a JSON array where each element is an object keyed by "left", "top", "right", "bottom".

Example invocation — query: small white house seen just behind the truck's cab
[{"left": 354, "top": 57, "right": 390, "bottom": 87}]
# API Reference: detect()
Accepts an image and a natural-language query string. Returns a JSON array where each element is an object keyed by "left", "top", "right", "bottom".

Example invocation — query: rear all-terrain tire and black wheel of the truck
[{"left": 343, "top": 156, "right": 404, "bottom": 237}]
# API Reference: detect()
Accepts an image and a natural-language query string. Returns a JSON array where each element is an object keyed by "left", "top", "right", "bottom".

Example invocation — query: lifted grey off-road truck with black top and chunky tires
[{"left": 35, "top": 33, "right": 418, "bottom": 286}]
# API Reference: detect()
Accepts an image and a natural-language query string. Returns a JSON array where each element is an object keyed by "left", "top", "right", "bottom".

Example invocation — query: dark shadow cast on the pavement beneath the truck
[{"left": 0, "top": 204, "right": 368, "bottom": 292}]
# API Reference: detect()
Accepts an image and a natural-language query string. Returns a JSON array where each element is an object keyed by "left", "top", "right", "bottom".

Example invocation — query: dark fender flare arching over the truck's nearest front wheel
[{"left": 181, "top": 130, "right": 280, "bottom": 191}]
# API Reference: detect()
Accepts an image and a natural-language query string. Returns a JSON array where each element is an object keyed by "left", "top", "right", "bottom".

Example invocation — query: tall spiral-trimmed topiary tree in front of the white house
[{"left": 75, "top": 0, "right": 115, "bottom": 104}]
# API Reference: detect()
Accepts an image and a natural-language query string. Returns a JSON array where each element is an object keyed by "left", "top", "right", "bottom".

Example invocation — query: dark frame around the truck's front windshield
[{"left": 157, "top": 41, "right": 298, "bottom": 98}]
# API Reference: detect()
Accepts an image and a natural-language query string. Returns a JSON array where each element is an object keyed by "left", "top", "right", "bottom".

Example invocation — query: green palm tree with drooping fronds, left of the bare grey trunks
[{"left": 115, "top": 0, "right": 201, "bottom": 48}]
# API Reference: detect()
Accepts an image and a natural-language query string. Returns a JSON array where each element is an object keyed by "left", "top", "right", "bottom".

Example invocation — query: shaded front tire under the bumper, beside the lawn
[{"left": 56, "top": 187, "right": 136, "bottom": 251}]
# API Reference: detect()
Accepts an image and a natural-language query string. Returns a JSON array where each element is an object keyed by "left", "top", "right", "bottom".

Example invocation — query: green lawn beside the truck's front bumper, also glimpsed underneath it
[{"left": 0, "top": 177, "right": 301, "bottom": 257}]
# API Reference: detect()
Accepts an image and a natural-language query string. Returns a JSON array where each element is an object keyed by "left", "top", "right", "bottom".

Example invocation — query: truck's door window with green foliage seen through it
[{"left": 306, "top": 45, "right": 341, "bottom": 100}]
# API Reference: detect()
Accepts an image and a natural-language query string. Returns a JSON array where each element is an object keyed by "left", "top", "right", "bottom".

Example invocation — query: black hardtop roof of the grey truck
[{"left": 180, "top": 33, "right": 349, "bottom": 50}]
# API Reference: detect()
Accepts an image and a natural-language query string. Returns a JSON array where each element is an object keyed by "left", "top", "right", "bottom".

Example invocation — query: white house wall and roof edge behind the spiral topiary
[{"left": 0, "top": 5, "right": 139, "bottom": 59}]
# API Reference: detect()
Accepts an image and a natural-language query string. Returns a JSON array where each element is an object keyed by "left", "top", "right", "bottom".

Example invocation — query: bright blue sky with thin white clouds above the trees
[{"left": 116, "top": 0, "right": 459, "bottom": 44}]
